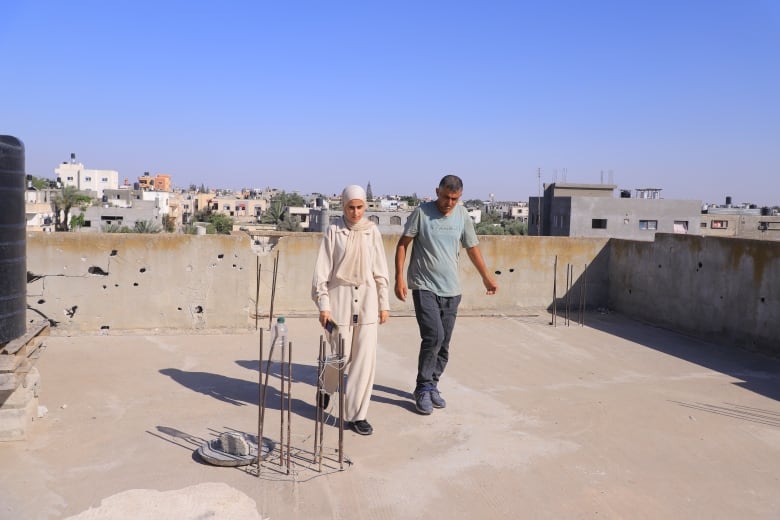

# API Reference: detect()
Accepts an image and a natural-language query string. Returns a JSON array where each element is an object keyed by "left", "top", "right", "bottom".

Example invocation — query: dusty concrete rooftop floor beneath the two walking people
[{"left": 0, "top": 313, "right": 780, "bottom": 520}]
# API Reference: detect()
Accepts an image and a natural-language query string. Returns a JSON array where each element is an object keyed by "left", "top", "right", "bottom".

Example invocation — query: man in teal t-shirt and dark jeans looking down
[{"left": 395, "top": 175, "right": 498, "bottom": 415}]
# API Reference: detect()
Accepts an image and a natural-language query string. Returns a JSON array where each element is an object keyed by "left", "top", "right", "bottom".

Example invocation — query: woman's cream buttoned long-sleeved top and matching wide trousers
[{"left": 312, "top": 219, "right": 390, "bottom": 421}]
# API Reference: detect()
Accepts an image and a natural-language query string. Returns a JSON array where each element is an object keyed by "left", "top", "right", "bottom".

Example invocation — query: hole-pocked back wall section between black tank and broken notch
[{"left": 27, "top": 233, "right": 257, "bottom": 334}]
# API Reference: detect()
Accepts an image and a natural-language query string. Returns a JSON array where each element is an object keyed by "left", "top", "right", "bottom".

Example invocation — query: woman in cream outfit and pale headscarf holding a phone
[{"left": 312, "top": 185, "right": 390, "bottom": 435}]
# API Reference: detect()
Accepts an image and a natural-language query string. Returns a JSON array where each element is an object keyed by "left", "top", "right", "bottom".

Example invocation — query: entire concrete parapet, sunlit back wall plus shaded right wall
[{"left": 27, "top": 233, "right": 780, "bottom": 360}]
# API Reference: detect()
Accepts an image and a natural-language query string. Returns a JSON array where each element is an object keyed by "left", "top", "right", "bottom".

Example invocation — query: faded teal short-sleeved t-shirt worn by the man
[{"left": 404, "top": 201, "right": 479, "bottom": 296}]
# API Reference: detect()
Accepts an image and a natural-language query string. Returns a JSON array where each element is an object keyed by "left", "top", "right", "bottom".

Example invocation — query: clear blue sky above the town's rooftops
[{"left": 0, "top": 0, "right": 780, "bottom": 205}]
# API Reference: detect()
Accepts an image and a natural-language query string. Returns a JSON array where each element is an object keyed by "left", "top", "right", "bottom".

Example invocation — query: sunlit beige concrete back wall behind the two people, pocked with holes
[{"left": 27, "top": 233, "right": 609, "bottom": 334}]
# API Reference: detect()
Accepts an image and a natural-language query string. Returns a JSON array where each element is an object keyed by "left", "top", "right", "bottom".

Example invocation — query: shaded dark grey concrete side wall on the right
[{"left": 609, "top": 234, "right": 780, "bottom": 355}]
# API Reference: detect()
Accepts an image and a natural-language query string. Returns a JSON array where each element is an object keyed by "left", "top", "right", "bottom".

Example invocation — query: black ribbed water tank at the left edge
[{"left": 0, "top": 135, "right": 27, "bottom": 343}]
